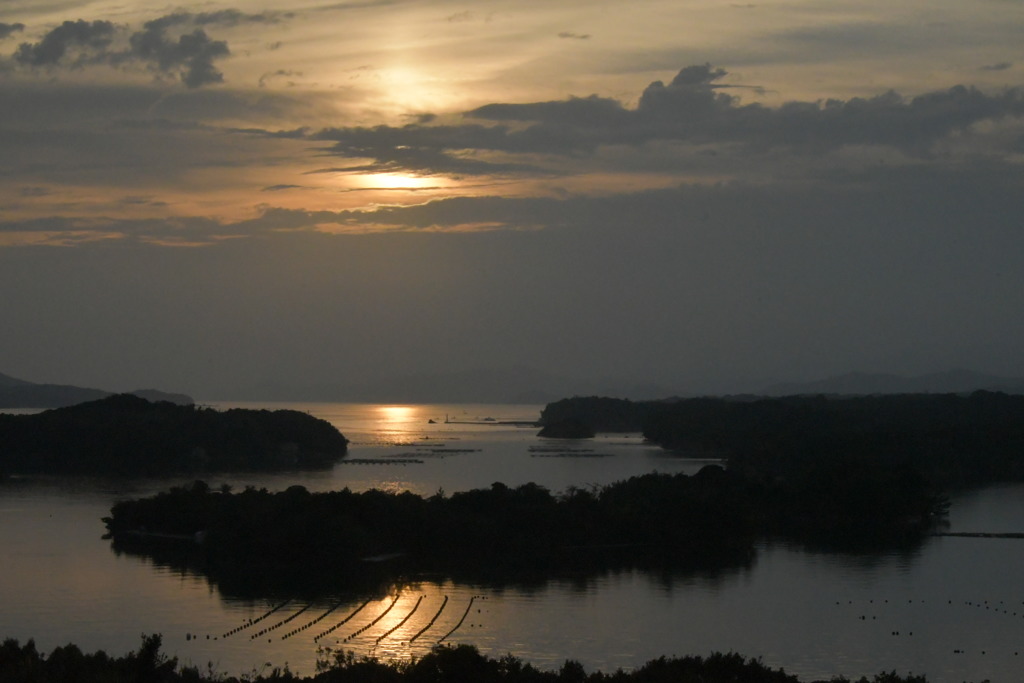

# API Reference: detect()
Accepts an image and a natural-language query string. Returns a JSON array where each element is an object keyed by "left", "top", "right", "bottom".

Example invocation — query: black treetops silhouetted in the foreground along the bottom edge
[{"left": 0, "top": 635, "right": 946, "bottom": 683}]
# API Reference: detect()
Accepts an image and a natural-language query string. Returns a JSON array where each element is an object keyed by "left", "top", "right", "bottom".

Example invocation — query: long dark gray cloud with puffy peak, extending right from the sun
[{"left": 311, "top": 63, "right": 1024, "bottom": 179}]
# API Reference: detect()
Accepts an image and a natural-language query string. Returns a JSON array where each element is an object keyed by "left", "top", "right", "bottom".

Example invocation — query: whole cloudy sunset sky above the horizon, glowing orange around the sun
[{"left": 0, "top": 0, "right": 1024, "bottom": 398}]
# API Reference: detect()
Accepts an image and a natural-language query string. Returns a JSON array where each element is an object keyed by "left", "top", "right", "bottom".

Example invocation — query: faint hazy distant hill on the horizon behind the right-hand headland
[{"left": 758, "top": 370, "right": 1024, "bottom": 396}]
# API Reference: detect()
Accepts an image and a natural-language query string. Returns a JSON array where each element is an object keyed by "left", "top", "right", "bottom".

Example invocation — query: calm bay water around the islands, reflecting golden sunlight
[{"left": 0, "top": 403, "right": 1024, "bottom": 683}]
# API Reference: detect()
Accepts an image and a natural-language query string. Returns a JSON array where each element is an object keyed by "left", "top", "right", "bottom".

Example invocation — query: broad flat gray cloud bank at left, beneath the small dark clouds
[{"left": 0, "top": 84, "right": 327, "bottom": 198}]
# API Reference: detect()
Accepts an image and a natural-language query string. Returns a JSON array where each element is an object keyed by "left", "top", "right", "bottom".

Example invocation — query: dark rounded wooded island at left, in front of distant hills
[{"left": 0, "top": 394, "right": 348, "bottom": 474}]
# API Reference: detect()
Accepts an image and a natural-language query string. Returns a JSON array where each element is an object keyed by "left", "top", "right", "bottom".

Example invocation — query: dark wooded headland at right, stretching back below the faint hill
[{"left": 542, "top": 391, "right": 1024, "bottom": 486}]
